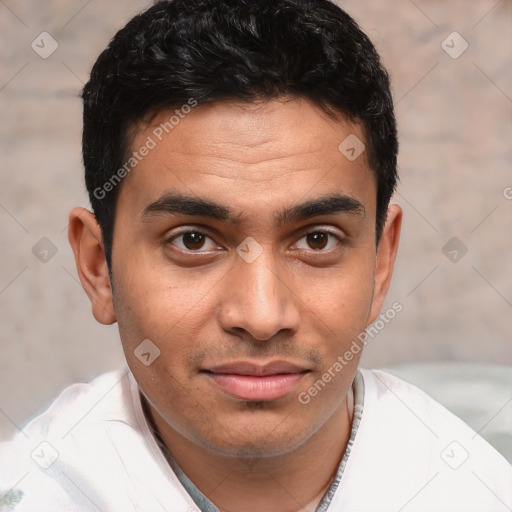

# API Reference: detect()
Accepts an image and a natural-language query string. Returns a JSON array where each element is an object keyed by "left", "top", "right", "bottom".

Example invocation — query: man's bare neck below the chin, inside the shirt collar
[{"left": 142, "top": 390, "right": 352, "bottom": 512}]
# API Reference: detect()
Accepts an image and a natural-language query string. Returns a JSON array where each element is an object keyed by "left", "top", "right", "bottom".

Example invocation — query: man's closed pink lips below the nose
[{"left": 201, "top": 361, "right": 310, "bottom": 401}]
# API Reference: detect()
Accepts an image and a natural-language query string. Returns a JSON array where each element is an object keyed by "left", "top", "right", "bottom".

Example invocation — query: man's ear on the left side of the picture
[{"left": 68, "top": 208, "right": 116, "bottom": 325}]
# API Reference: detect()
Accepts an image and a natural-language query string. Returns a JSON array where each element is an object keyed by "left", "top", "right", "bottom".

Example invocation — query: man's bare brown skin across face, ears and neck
[{"left": 69, "top": 99, "right": 401, "bottom": 512}]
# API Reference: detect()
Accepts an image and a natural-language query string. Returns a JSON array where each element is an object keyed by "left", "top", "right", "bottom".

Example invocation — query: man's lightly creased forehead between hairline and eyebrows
[{"left": 120, "top": 99, "right": 376, "bottom": 219}]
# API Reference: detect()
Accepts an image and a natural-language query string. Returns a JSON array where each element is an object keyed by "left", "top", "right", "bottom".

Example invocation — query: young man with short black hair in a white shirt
[{"left": 0, "top": 0, "right": 512, "bottom": 512}]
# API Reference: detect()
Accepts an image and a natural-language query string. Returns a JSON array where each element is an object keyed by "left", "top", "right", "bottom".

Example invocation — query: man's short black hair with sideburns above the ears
[{"left": 82, "top": 0, "right": 398, "bottom": 269}]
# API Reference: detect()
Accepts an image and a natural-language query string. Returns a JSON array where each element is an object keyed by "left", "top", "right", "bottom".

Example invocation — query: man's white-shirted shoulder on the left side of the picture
[{"left": 0, "top": 371, "right": 190, "bottom": 512}]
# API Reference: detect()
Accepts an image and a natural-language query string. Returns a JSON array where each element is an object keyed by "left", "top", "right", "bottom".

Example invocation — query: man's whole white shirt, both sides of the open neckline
[{"left": 0, "top": 370, "right": 512, "bottom": 512}]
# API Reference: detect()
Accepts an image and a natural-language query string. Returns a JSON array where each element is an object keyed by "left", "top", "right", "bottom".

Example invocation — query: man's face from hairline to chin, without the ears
[{"left": 88, "top": 100, "right": 398, "bottom": 456}]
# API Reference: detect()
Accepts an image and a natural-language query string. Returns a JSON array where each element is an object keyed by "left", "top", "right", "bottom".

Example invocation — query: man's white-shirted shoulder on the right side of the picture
[{"left": 334, "top": 369, "right": 512, "bottom": 512}]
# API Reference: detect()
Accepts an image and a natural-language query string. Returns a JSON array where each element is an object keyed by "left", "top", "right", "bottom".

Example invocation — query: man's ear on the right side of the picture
[{"left": 368, "top": 204, "right": 402, "bottom": 325}]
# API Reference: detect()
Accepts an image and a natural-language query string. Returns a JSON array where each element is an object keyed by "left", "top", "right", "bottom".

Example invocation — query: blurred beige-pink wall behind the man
[{"left": 0, "top": 0, "right": 512, "bottom": 437}]
